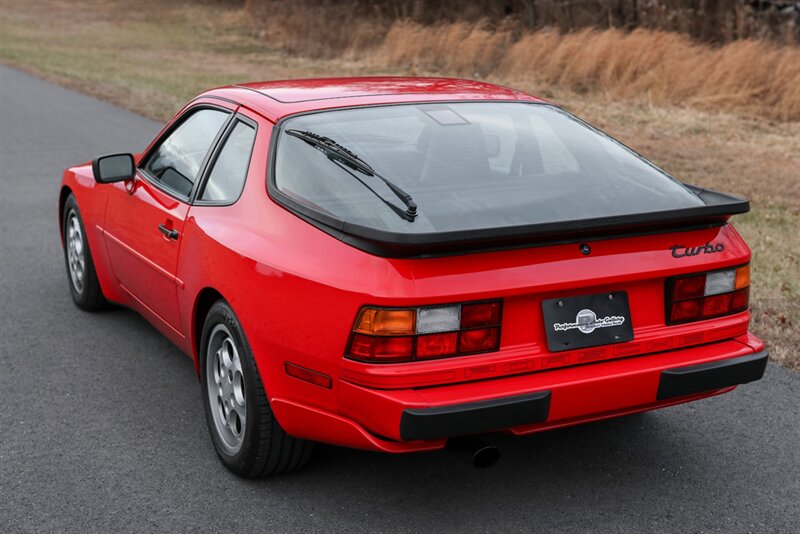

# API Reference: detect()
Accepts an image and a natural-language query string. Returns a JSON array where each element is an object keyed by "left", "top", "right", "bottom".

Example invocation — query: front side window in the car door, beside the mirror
[{"left": 144, "top": 109, "right": 230, "bottom": 197}]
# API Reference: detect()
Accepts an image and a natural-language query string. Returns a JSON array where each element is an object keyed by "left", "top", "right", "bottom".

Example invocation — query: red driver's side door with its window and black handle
[{"left": 104, "top": 106, "right": 232, "bottom": 336}]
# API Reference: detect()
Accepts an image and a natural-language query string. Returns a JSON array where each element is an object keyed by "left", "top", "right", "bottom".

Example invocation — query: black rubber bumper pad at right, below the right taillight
[{"left": 656, "top": 350, "right": 769, "bottom": 400}]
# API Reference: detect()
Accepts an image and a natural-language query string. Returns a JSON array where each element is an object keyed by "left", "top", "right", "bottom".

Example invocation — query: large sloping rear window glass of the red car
[{"left": 274, "top": 102, "right": 704, "bottom": 234}]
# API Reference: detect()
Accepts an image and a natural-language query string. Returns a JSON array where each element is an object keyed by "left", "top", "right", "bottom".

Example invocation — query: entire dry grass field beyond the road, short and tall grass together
[{"left": 0, "top": 0, "right": 800, "bottom": 370}]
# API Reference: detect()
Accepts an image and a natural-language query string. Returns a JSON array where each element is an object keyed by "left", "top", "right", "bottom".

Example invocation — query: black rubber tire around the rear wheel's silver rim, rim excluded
[{"left": 199, "top": 300, "right": 313, "bottom": 478}]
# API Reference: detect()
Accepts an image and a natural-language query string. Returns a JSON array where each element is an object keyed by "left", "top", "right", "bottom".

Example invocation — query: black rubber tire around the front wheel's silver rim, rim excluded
[{"left": 61, "top": 193, "right": 108, "bottom": 312}]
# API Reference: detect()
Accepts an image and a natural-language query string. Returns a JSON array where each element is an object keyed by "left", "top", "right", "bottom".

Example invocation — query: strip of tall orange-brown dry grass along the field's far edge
[{"left": 268, "top": 9, "right": 800, "bottom": 120}]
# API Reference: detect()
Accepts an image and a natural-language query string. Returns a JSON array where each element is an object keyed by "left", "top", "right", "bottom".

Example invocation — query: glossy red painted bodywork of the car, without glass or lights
[{"left": 63, "top": 78, "right": 763, "bottom": 452}]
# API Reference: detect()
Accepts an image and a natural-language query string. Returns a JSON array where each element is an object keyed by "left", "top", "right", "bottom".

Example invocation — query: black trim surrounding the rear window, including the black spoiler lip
[{"left": 266, "top": 99, "right": 750, "bottom": 258}]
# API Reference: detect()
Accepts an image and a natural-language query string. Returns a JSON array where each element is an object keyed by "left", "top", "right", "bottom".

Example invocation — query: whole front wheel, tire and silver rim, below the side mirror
[{"left": 61, "top": 194, "right": 107, "bottom": 311}]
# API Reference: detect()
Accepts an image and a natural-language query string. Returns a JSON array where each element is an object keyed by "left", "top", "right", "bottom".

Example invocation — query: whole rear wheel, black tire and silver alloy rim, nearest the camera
[{"left": 200, "top": 300, "right": 312, "bottom": 478}]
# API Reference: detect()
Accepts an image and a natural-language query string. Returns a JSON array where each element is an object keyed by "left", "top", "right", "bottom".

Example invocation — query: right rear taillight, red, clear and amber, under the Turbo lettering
[{"left": 665, "top": 265, "right": 750, "bottom": 324}]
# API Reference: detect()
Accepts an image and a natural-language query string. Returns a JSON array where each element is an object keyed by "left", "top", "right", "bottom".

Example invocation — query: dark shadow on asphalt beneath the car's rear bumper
[{"left": 242, "top": 413, "right": 703, "bottom": 515}]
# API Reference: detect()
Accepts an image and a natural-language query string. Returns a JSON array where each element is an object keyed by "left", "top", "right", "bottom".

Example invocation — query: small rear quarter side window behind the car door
[{"left": 200, "top": 121, "right": 256, "bottom": 203}]
